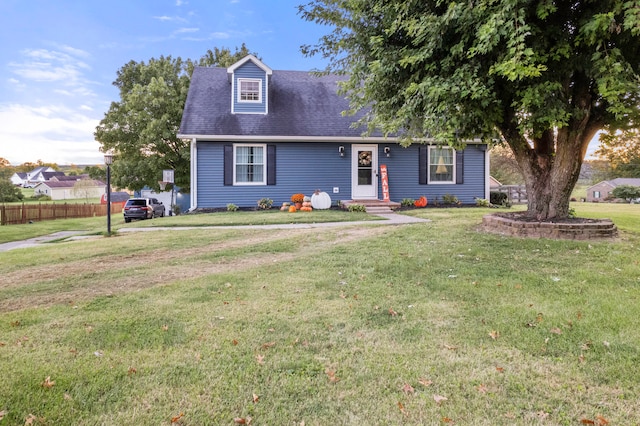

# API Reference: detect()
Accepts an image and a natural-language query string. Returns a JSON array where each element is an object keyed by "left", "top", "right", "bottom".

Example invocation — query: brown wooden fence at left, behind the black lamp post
[{"left": 0, "top": 203, "right": 122, "bottom": 225}]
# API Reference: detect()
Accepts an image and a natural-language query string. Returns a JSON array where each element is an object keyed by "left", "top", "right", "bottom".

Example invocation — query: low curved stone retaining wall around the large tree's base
[{"left": 482, "top": 214, "right": 618, "bottom": 240}]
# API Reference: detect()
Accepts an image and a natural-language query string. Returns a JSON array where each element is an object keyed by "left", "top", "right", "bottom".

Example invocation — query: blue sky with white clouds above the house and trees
[{"left": 0, "top": 0, "right": 329, "bottom": 164}]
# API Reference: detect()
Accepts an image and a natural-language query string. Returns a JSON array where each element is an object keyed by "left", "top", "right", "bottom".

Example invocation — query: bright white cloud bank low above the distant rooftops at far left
[{"left": 0, "top": 104, "right": 102, "bottom": 164}]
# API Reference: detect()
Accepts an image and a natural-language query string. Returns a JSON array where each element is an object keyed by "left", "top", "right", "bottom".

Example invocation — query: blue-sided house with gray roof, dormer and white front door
[{"left": 178, "top": 55, "right": 489, "bottom": 209}]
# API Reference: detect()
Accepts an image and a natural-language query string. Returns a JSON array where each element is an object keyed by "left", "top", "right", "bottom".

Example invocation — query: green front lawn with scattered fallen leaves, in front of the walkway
[{"left": 0, "top": 205, "right": 640, "bottom": 425}]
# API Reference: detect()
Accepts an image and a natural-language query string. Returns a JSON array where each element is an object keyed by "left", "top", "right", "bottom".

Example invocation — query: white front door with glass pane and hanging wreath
[{"left": 351, "top": 145, "right": 378, "bottom": 200}]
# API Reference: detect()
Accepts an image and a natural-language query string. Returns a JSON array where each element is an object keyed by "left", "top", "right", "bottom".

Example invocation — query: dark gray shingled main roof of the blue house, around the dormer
[{"left": 178, "top": 67, "right": 376, "bottom": 137}]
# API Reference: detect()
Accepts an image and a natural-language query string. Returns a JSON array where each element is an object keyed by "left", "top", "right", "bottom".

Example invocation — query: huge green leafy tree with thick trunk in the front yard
[{"left": 299, "top": 0, "right": 640, "bottom": 219}]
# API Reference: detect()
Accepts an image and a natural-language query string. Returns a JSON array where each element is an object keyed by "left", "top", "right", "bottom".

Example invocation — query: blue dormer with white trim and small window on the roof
[{"left": 227, "top": 55, "right": 273, "bottom": 114}]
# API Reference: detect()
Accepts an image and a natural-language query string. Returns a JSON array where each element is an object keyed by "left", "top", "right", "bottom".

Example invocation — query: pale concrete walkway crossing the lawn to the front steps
[{"left": 0, "top": 212, "right": 431, "bottom": 252}]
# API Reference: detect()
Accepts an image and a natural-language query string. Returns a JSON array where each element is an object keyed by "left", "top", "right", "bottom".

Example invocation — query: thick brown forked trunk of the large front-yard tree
[{"left": 502, "top": 120, "right": 597, "bottom": 221}]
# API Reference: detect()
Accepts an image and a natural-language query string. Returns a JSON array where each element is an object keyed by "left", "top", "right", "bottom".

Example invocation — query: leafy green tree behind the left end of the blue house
[{"left": 94, "top": 44, "right": 255, "bottom": 192}]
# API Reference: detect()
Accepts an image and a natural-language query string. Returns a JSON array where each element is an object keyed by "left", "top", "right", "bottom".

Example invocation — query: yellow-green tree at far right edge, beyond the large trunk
[{"left": 595, "top": 129, "right": 640, "bottom": 178}]
